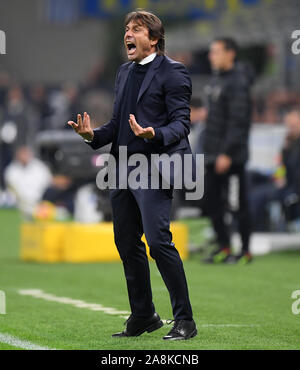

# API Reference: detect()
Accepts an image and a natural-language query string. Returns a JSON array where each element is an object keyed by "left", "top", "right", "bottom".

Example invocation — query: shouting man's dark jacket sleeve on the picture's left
[{"left": 86, "top": 69, "right": 120, "bottom": 150}]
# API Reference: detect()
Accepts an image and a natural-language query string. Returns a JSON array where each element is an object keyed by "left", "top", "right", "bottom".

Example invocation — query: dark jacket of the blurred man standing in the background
[{"left": 203, "top": 65, "right": 253, "bottom": 164}]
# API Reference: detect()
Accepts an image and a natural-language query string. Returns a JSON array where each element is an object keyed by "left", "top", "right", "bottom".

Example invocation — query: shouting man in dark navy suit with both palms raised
[{"left": 68, "top": 11, "right": 197, "bottom": 340}]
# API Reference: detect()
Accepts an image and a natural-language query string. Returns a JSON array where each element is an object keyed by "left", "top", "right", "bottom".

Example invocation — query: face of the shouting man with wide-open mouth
[{"left": 124, "top": 21, "right": 157, "bottom": 63}]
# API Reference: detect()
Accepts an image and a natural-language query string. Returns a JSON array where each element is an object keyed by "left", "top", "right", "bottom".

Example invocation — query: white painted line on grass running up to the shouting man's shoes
[{"left": 18, "top": 289, "right": 130, "bottom": 319}]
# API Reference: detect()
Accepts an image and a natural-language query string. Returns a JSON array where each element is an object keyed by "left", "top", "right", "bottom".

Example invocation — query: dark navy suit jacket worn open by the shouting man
[{"left": 89, "top": 55, "right": 192, "bottom": 186}]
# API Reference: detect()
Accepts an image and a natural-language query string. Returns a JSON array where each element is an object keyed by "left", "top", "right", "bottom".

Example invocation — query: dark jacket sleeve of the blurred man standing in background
[{"left": 220, "top": 81, "right": 251, "bottom": 157}]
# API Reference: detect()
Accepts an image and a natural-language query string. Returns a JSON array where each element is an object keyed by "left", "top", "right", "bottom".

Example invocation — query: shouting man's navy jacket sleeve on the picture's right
[{"left": 155, "top": 63, "right": 192, "bottom": 145}]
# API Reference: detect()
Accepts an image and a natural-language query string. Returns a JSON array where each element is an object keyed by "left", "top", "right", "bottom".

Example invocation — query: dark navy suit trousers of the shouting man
[{"left": 110, "top": 165, "right": 193, "bottom": 320}]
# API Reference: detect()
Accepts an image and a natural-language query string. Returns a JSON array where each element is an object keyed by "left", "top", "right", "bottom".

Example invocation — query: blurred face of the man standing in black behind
[{"left": 208, "top": 41, "right": 235, "bottom": 71}]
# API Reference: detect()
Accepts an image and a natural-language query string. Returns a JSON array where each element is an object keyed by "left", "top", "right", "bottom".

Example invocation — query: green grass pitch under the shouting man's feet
[{"left": 0, "top": 210, "right": 300, "bottom": 350}]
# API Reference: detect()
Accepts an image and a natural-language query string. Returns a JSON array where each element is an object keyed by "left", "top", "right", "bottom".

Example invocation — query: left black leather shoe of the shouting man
[{"left": 112, "top": 312, "right": 164, "bottom": 337}]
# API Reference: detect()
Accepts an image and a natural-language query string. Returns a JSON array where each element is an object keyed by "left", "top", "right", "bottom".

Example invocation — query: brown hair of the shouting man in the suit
[{"left": 124, "top": 9, "right": 165, "bottom": 55}]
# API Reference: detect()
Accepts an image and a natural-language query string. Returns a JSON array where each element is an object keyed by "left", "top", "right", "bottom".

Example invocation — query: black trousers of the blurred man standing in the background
[{"left": 204, "top": 164, "right": 251, "bottom": 252}]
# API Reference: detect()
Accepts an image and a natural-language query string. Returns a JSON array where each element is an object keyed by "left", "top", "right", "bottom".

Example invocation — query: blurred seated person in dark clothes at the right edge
[{"left": 250, "top": 108, "right": 300, "bottom": 231}]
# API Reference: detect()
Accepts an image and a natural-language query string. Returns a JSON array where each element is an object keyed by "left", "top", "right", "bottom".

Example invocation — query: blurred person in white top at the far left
[{"left": 4, "top": 146, "right": 52, "bottom": 218}]
